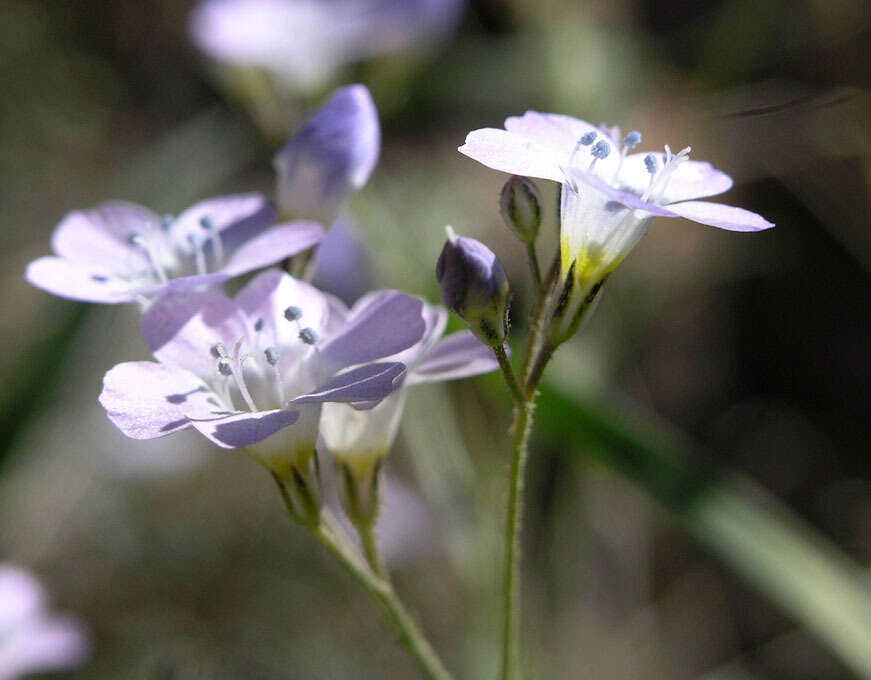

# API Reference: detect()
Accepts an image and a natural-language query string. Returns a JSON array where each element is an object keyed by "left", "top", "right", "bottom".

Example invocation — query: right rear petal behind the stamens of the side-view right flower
[{"left": 617, "top": 153, "right": 732, "bottom": 205}]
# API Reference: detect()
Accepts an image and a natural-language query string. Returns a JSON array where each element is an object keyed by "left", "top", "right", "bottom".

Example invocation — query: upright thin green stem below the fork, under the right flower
[{"left": 501, "top": 399, "right": 535, "bottom": 680}]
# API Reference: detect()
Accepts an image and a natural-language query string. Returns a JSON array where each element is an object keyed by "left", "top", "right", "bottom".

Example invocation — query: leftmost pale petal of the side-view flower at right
[{"left": 458, "top": 128, "right": 568, "bottom": 182}]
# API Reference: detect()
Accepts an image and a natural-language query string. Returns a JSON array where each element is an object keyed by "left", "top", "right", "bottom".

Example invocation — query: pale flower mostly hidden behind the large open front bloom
[{"left": 321, "top": 302, "right": 499, "bottom": 479}]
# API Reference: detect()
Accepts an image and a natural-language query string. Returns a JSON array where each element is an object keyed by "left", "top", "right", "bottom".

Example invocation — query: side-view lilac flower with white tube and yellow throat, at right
[{"left": 459, "top": 111, "right": 774, "bottom": 341}]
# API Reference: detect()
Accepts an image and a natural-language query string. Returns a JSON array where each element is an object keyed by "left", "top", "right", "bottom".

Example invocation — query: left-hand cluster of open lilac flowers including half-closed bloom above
[{"left": 26, "top": 85, "right": 496, "bottom": 519}]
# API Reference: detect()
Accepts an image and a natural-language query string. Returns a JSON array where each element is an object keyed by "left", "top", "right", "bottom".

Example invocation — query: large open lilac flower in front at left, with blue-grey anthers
[{"left": 100, "top": 270, "right": 425, "bottom": 478}]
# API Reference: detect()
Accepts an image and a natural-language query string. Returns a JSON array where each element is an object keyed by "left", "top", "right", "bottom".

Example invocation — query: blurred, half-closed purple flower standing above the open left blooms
[{"left": 273, "top": 85, "right": 381, "bottom": 226}]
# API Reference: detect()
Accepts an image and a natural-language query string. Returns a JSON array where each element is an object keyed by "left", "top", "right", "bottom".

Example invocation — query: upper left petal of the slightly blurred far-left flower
[{"left": 51, "top": 201, "right": 160, "bottom": 274}]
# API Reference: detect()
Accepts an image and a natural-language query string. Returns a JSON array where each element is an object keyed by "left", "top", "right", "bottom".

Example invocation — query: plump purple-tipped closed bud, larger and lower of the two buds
[{"left": 436, "top": 227, "right": 511, "bottom": 347}]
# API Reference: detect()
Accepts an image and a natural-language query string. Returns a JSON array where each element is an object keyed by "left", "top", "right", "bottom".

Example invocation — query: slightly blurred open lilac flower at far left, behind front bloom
[{"left": 26, "top": 194, "right": 323, "bottom": 307}]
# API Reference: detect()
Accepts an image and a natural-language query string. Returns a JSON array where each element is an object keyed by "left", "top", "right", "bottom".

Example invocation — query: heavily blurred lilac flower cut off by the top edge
[{"left": 190, "top": 0, "right": 463, "bottom": 90}]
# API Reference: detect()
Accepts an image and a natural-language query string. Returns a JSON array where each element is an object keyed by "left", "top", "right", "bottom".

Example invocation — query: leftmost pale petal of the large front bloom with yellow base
[{"left": 100, "top": 361, "right": 223, "bottom": 439}]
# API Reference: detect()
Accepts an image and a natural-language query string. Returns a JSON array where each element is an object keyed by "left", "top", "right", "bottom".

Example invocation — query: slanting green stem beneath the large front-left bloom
[{"left": 273, "top": 475, "right": 452, "bottom": 680}]
